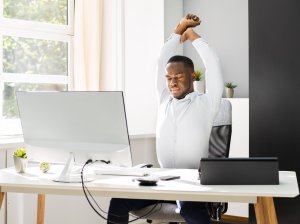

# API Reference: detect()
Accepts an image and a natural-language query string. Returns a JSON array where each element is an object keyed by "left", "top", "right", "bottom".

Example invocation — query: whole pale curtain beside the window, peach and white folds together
[{"left": 74, "top": 0, "right": 123, "bottom": 91}]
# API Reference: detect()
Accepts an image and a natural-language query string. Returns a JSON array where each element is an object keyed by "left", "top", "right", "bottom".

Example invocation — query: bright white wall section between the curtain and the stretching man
[{"left": 124, "top": 0, "right": 164, "bottom": 134}]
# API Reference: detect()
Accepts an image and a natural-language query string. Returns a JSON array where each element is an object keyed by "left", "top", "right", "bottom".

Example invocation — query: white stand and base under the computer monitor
[{"left": 53, "top": 152, "right": 94, "bottom": 183}]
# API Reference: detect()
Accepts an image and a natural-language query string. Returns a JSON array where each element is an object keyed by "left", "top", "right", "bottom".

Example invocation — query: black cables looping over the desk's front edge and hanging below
[{"left": 81, "top": 159, "right": 162, "bottom": 224}]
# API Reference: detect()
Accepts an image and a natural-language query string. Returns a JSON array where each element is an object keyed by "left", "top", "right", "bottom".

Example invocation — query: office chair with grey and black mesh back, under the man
[{"left": 130, "top": 99, "right": 232, "bottom": 223}]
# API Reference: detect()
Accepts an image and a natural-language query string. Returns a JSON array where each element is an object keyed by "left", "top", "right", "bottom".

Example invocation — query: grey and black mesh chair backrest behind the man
[{"left": 209, "top": 99, "right": 232, "bottom": 158}]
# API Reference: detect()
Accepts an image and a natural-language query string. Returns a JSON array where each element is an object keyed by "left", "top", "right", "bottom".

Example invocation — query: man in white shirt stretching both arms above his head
[{"left": 108, "top": 14, "right": 223, "bottom": 224}]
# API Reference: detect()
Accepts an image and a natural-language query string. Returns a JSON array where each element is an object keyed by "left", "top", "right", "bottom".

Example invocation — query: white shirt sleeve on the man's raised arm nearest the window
[{"left": 156, "top": 33, "right": 180, "bottom": 103}]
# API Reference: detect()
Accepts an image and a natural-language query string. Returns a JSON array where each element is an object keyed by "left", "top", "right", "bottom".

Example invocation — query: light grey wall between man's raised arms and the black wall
[{"left": 183, "top": 0, "right": 249, "bottom": 98}]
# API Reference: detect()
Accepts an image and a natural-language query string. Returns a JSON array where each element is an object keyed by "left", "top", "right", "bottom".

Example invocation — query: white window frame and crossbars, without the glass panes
[{"left": 0, "top": 0, "right": 74, "bottom": 135}]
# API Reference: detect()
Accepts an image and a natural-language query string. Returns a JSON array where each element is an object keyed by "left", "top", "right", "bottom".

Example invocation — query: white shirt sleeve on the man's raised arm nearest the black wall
[{"left": 192, "top": 38, "right": 223, "bottom": 115}]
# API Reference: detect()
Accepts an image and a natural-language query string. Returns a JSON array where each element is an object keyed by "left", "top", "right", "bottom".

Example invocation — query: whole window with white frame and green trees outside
[{"left": 0, "top": 0, "right": 74, "bottom": 134}]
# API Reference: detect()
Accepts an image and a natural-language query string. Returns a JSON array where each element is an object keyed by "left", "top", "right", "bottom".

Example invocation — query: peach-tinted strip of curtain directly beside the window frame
[{"left": 74, "top": 0, "right": 103, "bottom": 90}]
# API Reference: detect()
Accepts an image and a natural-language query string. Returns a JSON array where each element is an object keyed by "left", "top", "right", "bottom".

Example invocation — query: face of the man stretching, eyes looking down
[{"left": 166, "top": 62, "right": 195, "bottom": 99}]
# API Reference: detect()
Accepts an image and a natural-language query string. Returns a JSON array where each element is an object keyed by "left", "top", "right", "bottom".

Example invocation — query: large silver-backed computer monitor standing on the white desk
[{"left": 16, "top": 91, "right": 132, "bottom": 182}]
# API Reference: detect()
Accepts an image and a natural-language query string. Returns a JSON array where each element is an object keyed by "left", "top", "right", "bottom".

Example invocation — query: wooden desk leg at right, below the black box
[{"left": 254, "top": 197, "right": 278, "bottom": 224}]
